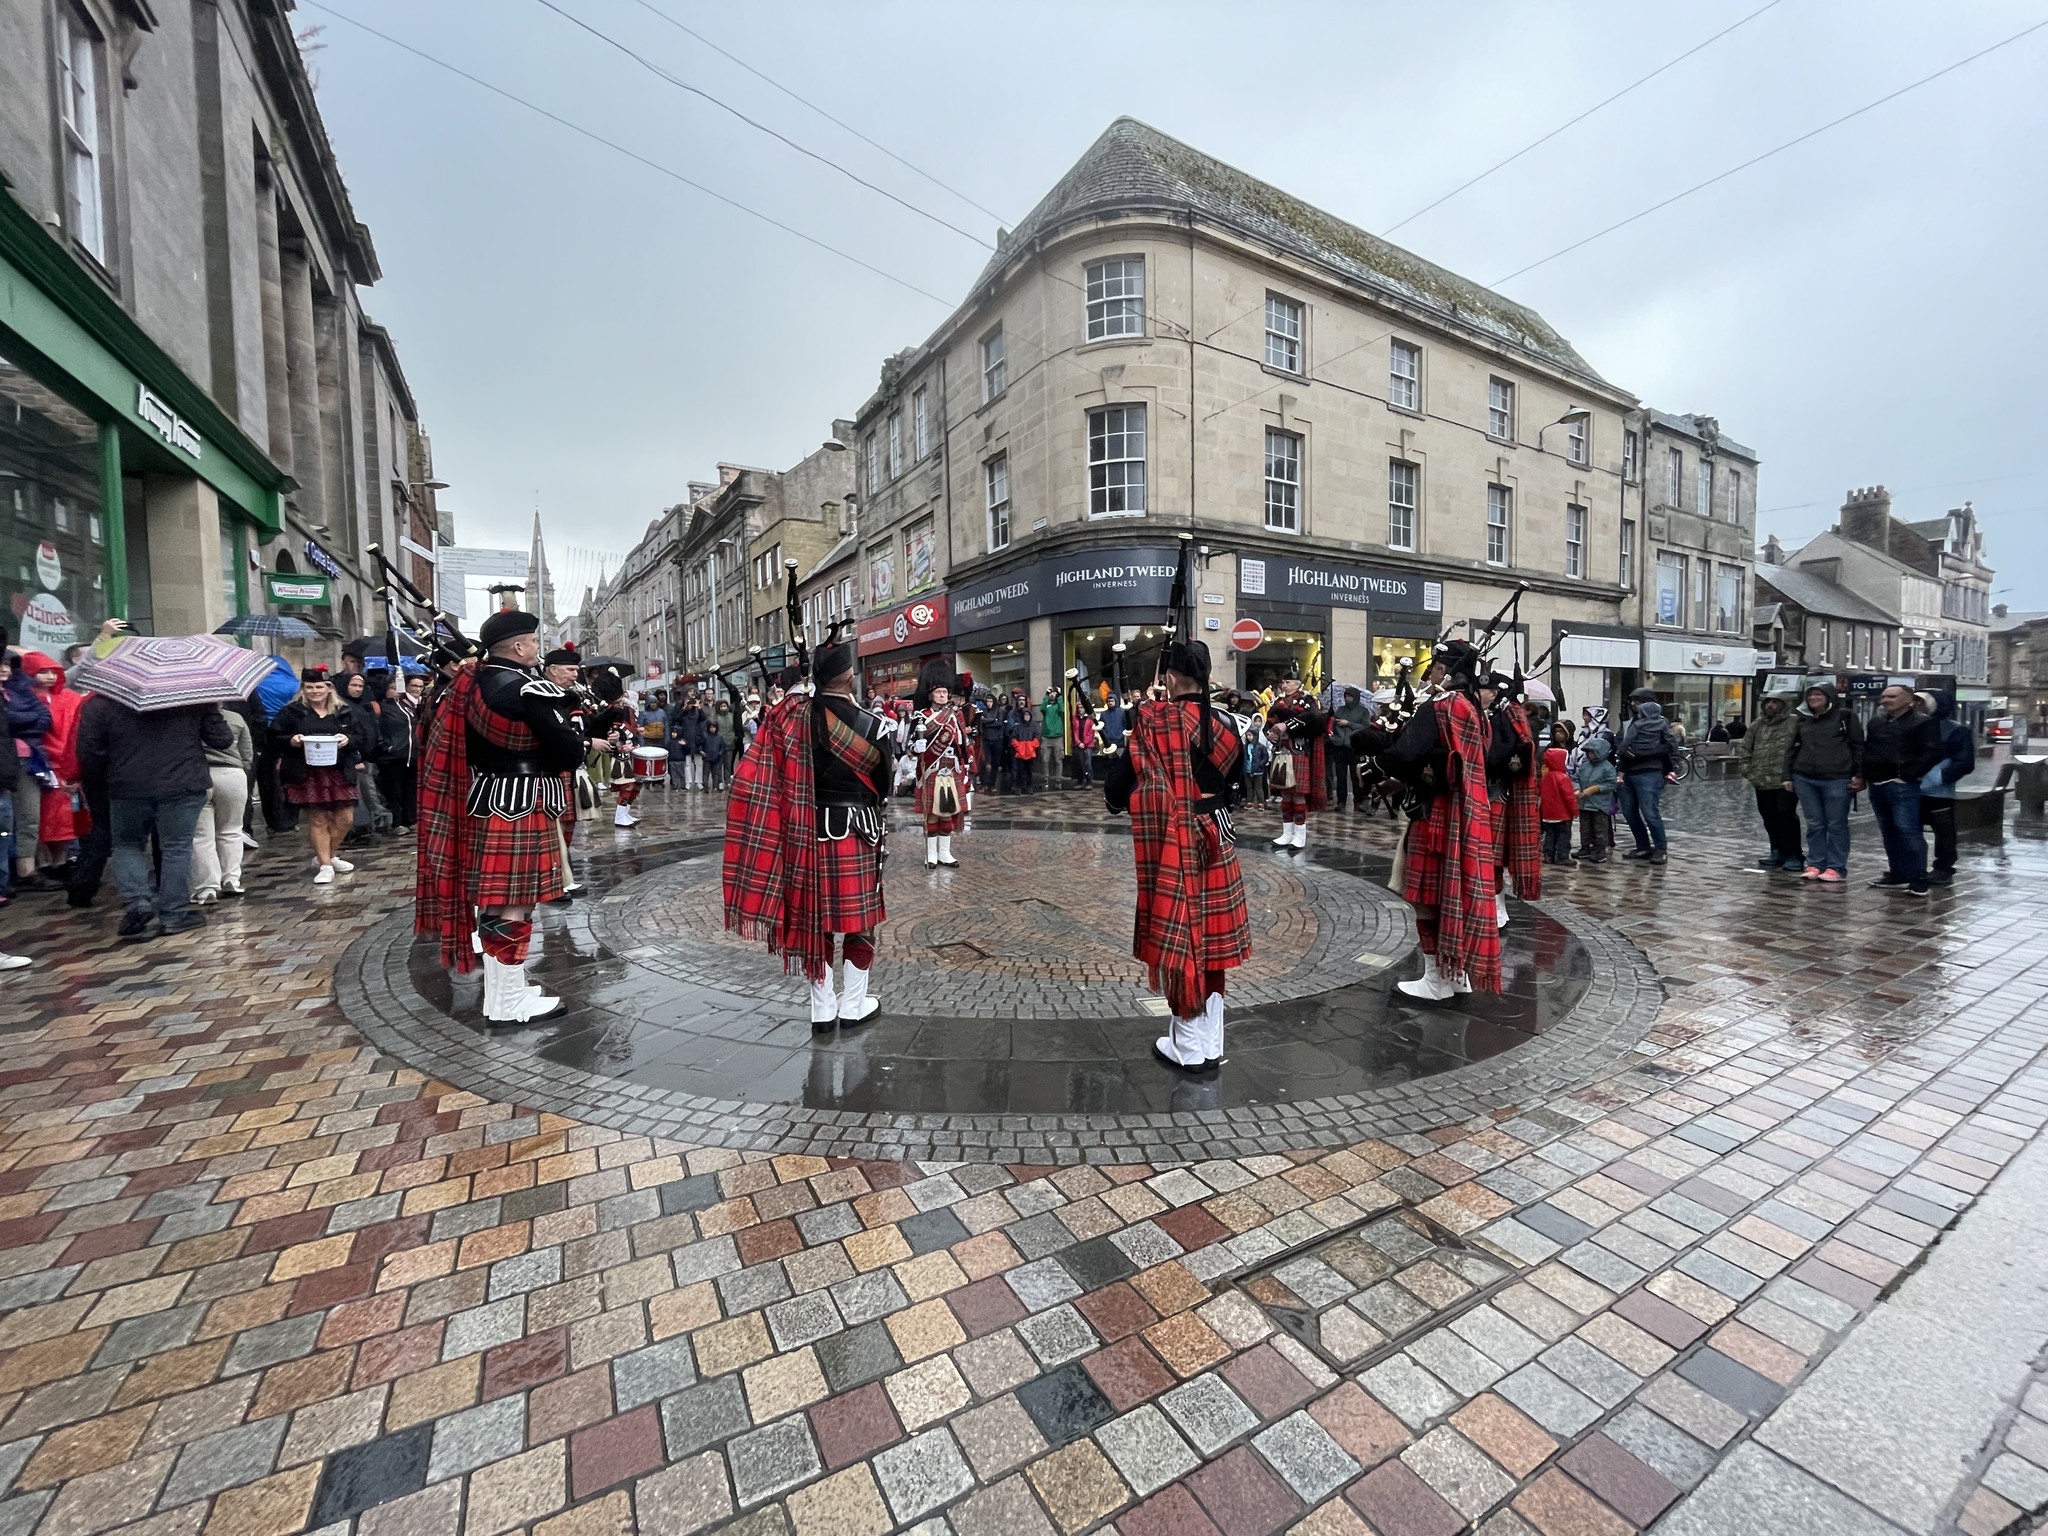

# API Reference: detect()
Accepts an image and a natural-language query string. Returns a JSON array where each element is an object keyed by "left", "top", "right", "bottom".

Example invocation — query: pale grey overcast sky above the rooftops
[{"left": 297, "top": 0, "right": 2048, "bottom": 608}]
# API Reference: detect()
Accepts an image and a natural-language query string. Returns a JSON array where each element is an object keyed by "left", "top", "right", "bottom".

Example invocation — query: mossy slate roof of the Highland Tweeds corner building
[{"left": 977, "top": 117, "right": 1606, "bottom": 383}]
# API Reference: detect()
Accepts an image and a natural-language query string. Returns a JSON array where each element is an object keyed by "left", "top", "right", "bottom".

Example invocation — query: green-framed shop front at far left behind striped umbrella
[{"left": 0, "top": 190, "right": 291, "bottom": 653}]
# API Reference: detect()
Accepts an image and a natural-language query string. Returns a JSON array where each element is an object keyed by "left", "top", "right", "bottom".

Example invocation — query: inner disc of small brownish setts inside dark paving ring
[{"left": 590, "top": 829, "right": 1415, "bottom": 1020}]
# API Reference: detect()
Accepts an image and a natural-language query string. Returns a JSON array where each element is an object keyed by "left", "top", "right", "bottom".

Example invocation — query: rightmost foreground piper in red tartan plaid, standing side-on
[{"left": 1380, "top": 641, "right": 1501, "bottom": 1001}]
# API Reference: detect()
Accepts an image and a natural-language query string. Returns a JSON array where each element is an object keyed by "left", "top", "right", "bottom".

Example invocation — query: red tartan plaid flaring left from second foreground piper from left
[{"left": 725, "top": 694, "right": 881, "bottom": 981}]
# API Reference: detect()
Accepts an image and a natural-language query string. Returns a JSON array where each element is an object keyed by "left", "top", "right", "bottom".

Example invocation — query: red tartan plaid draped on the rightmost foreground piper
[{"left": 1401, "top": 694, "right": 1501, "bottom": 991}]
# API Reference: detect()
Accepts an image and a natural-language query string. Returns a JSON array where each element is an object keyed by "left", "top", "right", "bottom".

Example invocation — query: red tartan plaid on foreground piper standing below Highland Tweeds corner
[{"left": 1130, "top": 698, "right": 1251, "bottom": 1018}]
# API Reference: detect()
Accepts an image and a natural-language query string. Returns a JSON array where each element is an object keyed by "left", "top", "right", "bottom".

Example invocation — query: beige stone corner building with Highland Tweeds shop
[{"left": 831, "top": 117, "right": 1755, "bottom": 729}]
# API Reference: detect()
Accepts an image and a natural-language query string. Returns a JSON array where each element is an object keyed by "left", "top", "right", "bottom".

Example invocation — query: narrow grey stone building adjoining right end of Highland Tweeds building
[{"left": 1622, "top": 410, "right": 1757, "bottom": 739}]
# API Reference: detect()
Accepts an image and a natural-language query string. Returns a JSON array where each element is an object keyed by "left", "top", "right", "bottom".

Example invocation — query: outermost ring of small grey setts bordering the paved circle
[{"left": 334, "top": 843, "right": 1665, "bottom": 1165}]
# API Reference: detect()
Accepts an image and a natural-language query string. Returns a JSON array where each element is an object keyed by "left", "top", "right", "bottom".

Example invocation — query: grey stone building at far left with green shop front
[{"left": 0, "top": 0, "right": 442, "bottom": 655}]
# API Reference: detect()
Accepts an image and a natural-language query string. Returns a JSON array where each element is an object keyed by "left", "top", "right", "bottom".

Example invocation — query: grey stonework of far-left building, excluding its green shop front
[{"left": 0, "top": 0, "right": 442, "bottom": 659}]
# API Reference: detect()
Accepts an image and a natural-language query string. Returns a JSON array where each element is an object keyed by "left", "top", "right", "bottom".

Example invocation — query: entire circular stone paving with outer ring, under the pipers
[{"left": 336, "top": 821, "right": 1661, "bottom": 1163}]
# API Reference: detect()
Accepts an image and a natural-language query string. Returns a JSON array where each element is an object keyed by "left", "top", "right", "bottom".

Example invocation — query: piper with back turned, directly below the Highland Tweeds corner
[{"left": 1104, "top": 641, "right": 1251, "bottom": 1073}]
